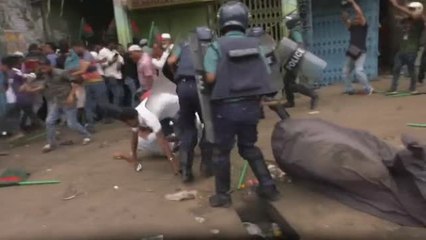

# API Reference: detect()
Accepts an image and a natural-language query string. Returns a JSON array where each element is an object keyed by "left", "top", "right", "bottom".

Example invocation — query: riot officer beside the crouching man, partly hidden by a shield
[{"left": 167, "top": 32, "right": 213, "bottom": 183}]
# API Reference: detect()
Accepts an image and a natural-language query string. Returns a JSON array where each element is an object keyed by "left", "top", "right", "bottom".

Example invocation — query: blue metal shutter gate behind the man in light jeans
[{"left": 301, "top": 0, "right": 380, "bottom": 86}]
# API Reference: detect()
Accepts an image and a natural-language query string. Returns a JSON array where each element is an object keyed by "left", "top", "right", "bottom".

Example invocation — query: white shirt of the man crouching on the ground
[{"left": 132, "top": 93, "right": 179, "bottom": 134}]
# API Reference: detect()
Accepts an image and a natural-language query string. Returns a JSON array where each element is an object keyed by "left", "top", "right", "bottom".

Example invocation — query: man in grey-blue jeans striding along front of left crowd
[{"left": 40, "top": 59, "right": 91, "bottom": 153}]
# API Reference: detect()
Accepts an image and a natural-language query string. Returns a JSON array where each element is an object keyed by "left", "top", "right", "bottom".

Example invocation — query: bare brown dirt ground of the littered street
[{"left": 0, "top": 77, "right": 426, "bottom": 240}]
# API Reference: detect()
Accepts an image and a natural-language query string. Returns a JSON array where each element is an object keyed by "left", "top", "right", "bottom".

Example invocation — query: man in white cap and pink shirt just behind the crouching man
[{"left": 129, "top": 45, "right": 156, "bottom": 94}]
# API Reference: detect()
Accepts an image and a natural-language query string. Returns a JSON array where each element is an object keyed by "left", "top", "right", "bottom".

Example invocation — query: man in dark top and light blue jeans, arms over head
[{"left": 342, "top": 0, "right": 374, "bottom": 95}]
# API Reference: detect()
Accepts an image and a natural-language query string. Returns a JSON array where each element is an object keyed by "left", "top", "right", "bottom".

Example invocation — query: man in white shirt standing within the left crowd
[{"left": 98, "top": 42, "right": 124, "bottom": 106}]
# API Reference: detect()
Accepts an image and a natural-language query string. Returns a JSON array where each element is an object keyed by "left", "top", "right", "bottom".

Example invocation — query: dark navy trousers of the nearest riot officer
[{"left": 212, "top": 100, "right": 274, "bottom": 195}]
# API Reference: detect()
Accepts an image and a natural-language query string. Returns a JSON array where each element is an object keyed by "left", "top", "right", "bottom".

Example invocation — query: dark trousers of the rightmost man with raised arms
[{"left": 390, "top": 52, "right": 417, "bottom": 91}]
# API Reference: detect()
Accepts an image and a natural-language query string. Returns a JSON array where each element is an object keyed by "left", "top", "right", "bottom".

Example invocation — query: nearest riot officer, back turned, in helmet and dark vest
[{"left": 204, "top": 1, "right": 279, "bottom": 207}]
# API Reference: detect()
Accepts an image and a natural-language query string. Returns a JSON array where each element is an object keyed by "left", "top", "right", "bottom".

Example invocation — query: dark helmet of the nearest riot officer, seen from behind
[{"left": 217, "top": 1, "right": 251, "bottom": 30}]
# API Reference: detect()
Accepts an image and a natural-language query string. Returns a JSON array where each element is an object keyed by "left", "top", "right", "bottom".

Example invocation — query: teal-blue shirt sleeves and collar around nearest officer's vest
[{"left": 204, "top": 31, "right": 271, "bottom": 73}]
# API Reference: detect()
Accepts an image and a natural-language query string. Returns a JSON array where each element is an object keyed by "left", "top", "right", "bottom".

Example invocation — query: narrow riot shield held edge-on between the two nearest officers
[{"left": 189, "top": 27, "right": 214, "bottom": 143}]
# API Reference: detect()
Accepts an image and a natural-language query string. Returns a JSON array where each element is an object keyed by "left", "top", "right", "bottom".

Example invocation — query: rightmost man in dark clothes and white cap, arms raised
[{"left": 388, "top": 0, "right": 425, "bottom": 94}]
